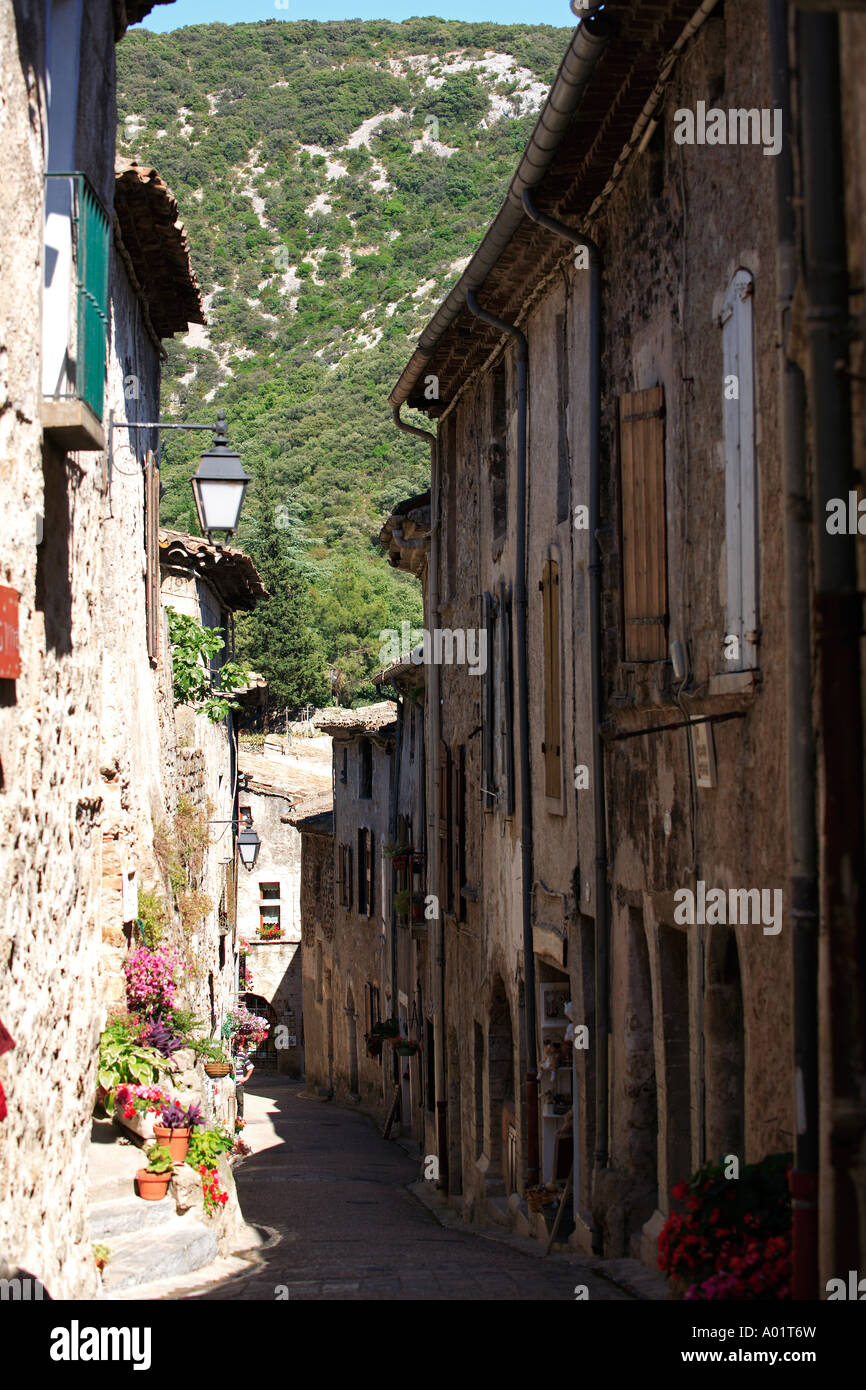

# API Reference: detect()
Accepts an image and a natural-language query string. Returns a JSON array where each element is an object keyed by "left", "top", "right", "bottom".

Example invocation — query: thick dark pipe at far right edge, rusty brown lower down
[{"left": 796, "top": 13, "right": 866, "bottom": 1275}]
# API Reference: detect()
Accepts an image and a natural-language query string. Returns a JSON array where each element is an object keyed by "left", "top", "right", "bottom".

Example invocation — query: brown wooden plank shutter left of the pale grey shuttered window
[{"left": 620, "top": 386, "right": 667, "bottom": 662}]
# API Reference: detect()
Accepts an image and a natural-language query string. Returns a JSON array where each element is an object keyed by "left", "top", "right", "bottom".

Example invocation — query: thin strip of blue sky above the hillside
[{"left": 142, "top": 0, "right": 577, "bottom": 33}]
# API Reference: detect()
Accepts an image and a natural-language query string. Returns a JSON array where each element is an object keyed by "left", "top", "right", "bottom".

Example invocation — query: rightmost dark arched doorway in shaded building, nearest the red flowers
[{"left": 703, "top": 926, "right": 745, "bottom": 1162}]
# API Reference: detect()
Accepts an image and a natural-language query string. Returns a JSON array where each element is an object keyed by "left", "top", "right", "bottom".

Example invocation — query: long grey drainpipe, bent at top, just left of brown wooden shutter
[{"left": 523, "top": 190, "right": 610, "bottom": 1173}]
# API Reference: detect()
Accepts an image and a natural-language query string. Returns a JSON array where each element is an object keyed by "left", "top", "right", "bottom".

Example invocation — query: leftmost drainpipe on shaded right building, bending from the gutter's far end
[{"left": 392, "top": 406, "right": 448, "bottom": 1190}]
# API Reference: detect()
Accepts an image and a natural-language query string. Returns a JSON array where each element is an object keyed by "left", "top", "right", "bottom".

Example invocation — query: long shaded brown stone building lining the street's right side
[{"left": 391, "top": 0, "right": 863, "bottom": 1294}]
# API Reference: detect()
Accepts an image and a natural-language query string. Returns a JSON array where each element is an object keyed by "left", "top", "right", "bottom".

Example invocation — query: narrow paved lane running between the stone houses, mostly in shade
[{"left": 193, "top": 1077, "right": 631, "bottom": 1301}]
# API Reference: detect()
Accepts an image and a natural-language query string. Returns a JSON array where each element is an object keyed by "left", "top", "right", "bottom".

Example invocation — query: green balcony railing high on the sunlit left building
[{"left": 46, "top": 172, "right": 110, "bottom": 420}]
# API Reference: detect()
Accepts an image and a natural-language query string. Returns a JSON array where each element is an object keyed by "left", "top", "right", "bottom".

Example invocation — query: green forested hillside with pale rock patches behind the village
[{"left": 118, "top": 19, "right": 570, "bottom": 706}]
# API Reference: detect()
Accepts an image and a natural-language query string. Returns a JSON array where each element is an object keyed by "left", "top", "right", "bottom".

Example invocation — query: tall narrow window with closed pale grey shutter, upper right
[{"left": 720, "top": 270, "right": 760, "bottom": 670}]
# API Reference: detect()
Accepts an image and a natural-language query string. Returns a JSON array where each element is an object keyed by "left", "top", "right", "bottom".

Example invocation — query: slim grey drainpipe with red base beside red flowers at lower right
[{"left": 767, "top": 0, "right": 819, "bottom": 1300}]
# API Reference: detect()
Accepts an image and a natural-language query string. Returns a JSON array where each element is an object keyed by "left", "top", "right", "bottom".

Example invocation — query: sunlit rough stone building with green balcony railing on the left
[{"left": 0, "top": 0, "right": 208, "bottom": 1298}]
